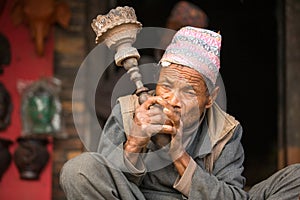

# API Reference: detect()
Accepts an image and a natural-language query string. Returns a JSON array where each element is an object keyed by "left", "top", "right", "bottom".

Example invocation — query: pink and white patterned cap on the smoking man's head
[{"left": 160, "top": 26, "right": 221, "bottom": 85}]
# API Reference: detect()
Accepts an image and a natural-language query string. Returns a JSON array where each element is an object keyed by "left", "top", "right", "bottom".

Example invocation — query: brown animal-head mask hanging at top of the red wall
[{"left": 11, "top": 0, "right": 71, "bottom": 56}]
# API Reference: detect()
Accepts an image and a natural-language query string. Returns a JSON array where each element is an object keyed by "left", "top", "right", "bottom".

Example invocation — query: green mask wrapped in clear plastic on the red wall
[{"left": 21, "top": 78, "right": 62, "bottom": 135}]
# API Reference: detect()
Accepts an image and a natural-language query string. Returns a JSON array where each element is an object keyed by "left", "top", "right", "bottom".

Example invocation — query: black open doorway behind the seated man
[{"left": 117, "top": 0, "right": 278, "bottom": 186}]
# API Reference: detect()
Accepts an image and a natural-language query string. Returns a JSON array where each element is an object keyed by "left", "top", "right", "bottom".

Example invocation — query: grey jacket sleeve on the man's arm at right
[{"left": 189, "top": 125, "right": 248, "bottom": 200}]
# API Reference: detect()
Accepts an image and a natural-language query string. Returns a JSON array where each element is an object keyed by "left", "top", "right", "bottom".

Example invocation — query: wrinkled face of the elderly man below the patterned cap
[{"left": 156, "top": 64, "right": 211, "bottom": 129}]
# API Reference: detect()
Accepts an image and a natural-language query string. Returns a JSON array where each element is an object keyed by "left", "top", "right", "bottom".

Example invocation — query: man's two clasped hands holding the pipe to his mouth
[{"left": 124, "top": 96, "right": 189, "bottom": 172}]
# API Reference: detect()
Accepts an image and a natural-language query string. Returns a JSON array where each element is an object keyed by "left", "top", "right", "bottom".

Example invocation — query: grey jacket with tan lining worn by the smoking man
[{"left": 98, "top": 96, "right": 248, "bottom": 199}]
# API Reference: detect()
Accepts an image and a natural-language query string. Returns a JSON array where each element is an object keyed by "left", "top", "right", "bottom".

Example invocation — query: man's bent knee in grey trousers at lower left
[{"left": 60, "top": 153, "right": 136, "bottom": 199}]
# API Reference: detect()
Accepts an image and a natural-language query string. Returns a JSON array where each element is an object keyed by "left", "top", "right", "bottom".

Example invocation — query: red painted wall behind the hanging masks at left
[{"left": 0, "top": 0, "right": 54, "bottom": 200}]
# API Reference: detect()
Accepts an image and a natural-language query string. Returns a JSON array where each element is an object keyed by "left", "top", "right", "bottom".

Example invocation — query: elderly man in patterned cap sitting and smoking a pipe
[{"left": 61, "top": 27, "right": 300, "bottom": 200}]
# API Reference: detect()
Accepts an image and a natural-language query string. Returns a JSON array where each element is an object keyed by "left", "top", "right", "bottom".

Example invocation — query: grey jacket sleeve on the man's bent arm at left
[{"left": 98, "top": 104, "right": 146, "bottom": 185}]
